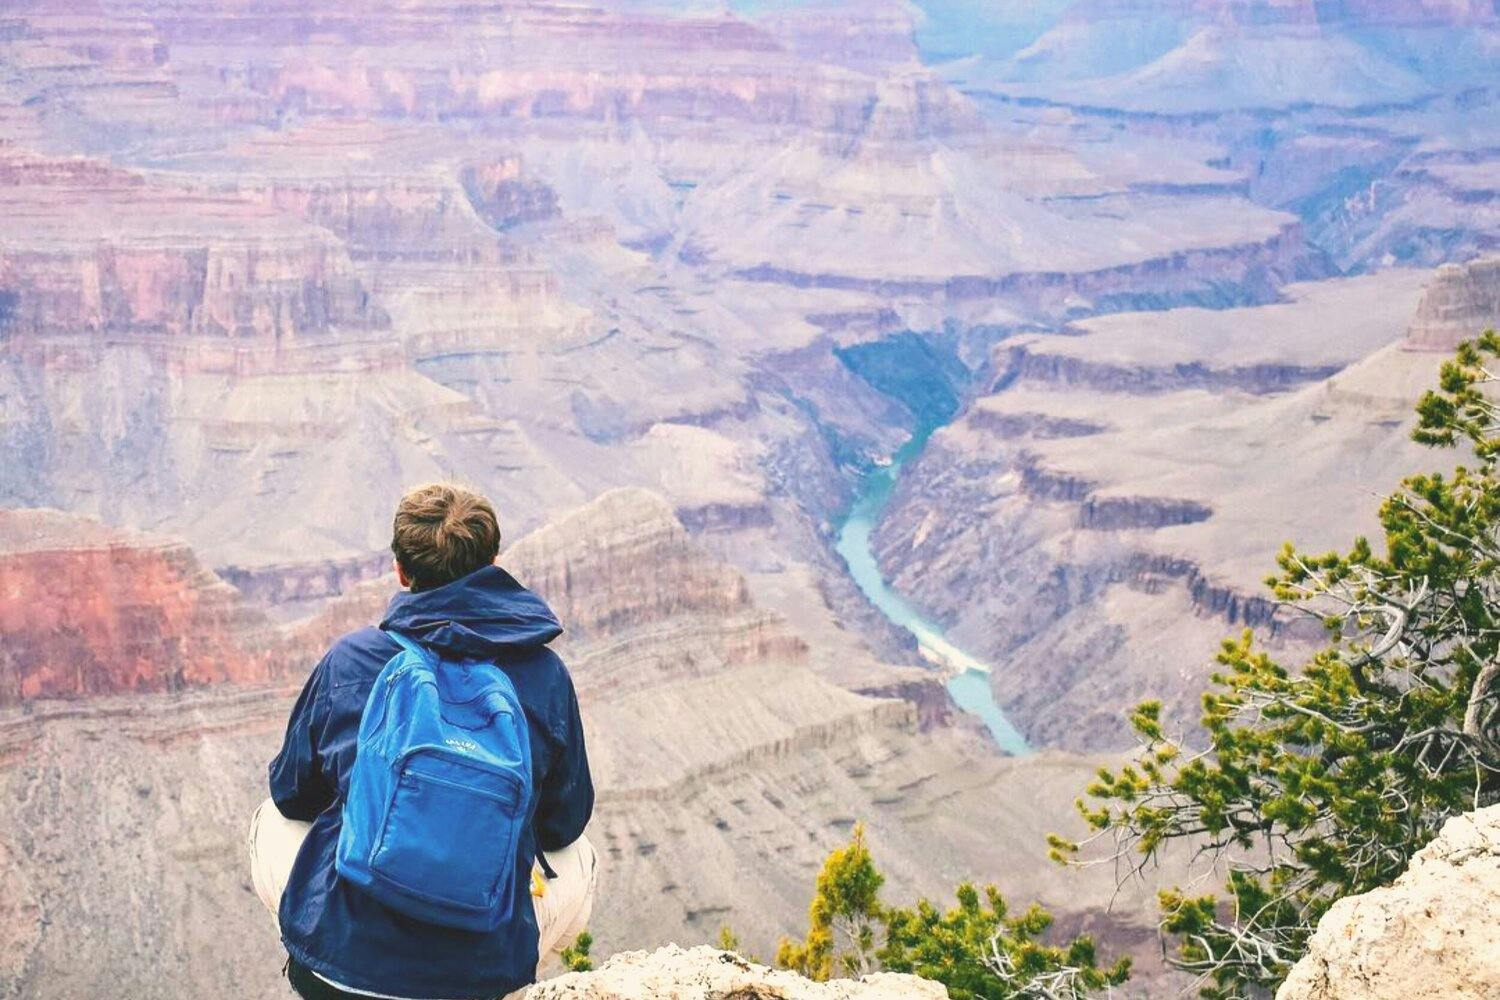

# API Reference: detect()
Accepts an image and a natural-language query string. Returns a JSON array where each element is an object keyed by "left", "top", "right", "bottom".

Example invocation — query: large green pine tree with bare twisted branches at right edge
[{"left": 1052, "top": 331, "right": 1500, "bottom": 1000}]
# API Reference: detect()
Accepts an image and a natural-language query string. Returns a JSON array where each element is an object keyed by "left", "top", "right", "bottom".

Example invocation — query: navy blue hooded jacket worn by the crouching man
[{"left": 270, "top": 567, "right": 594, "bottom": 1000}]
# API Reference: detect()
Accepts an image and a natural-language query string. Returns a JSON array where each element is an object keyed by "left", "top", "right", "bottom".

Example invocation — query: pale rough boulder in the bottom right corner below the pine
[{"left": 1277, "top": 807, "right": 1500, "bottom": 1000}]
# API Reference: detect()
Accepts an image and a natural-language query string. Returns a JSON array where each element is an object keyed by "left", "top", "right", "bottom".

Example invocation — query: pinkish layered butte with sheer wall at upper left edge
[{"left": 0, "top": 151, "right": 389, "bottom": 349}]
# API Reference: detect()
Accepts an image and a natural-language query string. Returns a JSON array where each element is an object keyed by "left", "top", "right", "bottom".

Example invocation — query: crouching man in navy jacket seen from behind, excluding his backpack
[{"left": 251, "top": 484, "right": 596, "bottom": 1000}]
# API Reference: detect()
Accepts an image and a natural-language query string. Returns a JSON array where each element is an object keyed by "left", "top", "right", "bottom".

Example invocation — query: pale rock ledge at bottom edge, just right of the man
[{"left": 527, "top": 945, "right": 948, "bottom": 1000}]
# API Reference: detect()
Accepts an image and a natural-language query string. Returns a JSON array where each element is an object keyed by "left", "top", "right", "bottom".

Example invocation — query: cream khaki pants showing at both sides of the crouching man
[{"left": 249, "top": 799, "right": 599, "bottom": 997}]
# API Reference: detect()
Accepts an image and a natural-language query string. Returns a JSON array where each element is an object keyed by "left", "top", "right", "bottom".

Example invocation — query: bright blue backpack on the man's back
[{"left": 335, "top": 631, "right": 531, "bottom": 931}]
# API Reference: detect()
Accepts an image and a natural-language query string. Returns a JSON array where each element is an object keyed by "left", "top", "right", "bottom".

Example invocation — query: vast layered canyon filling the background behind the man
[{"left": 0, "top": 0, "right": 1500, "bottom": 997}]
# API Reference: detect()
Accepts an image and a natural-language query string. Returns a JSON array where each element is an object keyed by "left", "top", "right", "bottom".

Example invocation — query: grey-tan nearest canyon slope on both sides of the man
[{"left": 0, "top": 490, "right": 1160, "bottom": 1000}]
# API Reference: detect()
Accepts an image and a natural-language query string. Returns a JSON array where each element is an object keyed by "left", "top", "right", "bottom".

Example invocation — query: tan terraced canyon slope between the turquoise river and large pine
[{"left": 876, "top": 273, "right": 1442, "bottom": 748}]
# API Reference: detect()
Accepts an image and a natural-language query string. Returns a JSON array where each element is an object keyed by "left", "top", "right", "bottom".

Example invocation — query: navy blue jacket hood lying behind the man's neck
[{"left": 380, "top": 565, "right": 563, "bottom": 660}]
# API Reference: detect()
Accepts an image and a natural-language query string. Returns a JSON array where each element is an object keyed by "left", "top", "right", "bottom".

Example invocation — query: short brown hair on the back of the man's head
[{"left": 390, "top": 483, "right": 500, "bottom": 591}]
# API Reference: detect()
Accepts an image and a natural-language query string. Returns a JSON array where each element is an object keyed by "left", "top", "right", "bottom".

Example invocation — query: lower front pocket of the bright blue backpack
[{"left": 371, "top": 748, "right": 524, "bottom": 927}]
